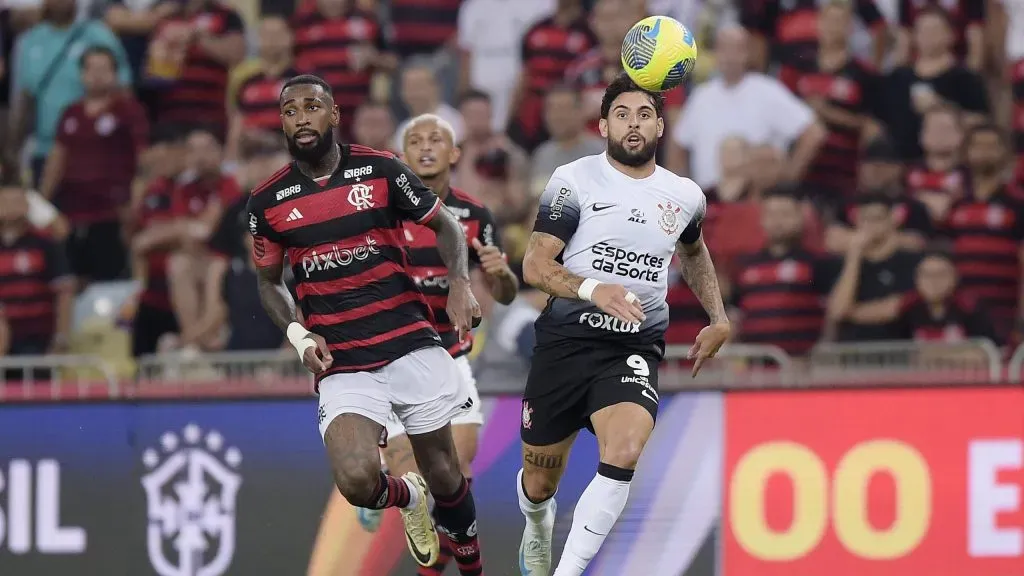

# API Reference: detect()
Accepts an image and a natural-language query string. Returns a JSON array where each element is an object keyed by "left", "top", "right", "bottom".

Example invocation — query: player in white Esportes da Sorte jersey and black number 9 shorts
[{"left": 516, "top": 75, "right": 730, "bottom": 576}]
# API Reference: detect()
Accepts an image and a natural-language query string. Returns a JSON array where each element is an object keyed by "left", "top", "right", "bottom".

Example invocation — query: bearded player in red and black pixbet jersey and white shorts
[{"left": 249, "top": 76, "right": 482, "bottom": 575}]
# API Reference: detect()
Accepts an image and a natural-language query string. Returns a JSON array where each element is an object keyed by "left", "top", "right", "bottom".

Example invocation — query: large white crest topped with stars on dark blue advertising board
[{"left": 142, "top": 424, "right": 242, "bottom": 576}]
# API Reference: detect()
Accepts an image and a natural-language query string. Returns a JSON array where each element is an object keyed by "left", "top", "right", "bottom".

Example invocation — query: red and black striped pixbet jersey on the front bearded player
[{"left": 248, "top": 145, "right": 441, "bottom": 377}]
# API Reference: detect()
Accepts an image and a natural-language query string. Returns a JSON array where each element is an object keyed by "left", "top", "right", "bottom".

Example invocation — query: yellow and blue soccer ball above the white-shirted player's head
[{"left": 623, "top": 16, "right": 697, "bottom": 92}]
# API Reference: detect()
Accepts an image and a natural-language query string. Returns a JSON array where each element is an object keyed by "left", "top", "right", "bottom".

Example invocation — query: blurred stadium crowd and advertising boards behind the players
[{"left": 0, "top": 0, "right": 1024, "bottom": 576}]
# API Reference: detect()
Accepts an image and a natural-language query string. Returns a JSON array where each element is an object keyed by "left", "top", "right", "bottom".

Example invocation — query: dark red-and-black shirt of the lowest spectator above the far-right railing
[{"left": 896, "top": 292, "right": 999, "bottom": 342}]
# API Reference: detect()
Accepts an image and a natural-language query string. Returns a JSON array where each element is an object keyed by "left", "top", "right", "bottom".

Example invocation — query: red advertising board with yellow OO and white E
[{"left": 723, "top": 388, "right": 1024, "bottom": 576}]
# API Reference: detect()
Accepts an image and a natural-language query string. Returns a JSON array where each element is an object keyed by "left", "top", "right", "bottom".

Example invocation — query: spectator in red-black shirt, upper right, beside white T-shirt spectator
[{"left": 797, "top": 4, "right": 881, "bottom": 204}]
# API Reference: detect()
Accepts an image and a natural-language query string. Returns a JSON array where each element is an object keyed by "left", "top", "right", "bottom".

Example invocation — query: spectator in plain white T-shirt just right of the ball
[{"left": 668, "top": 27, "right": 826, "bottom": 187}]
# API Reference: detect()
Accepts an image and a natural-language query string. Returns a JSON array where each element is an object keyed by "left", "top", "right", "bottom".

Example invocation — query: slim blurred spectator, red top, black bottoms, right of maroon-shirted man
[{"left": 130, "top": 126, "right": 185, "bottom": 357}]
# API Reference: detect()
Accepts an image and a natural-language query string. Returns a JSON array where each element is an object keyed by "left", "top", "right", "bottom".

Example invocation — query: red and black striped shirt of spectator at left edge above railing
[{"left": 0, "top": 232, "right": 73, "bottom": 342}]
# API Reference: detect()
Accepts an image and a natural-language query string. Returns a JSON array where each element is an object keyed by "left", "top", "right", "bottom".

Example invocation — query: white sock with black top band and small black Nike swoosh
[{"left": 554, "top": 464, "right": 633, "bottom": 576}]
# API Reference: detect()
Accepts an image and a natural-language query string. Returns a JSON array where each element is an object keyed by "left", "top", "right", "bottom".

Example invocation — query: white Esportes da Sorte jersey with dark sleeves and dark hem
[{"left": 534, "top": 153, "right": 707, "bottom": 347}]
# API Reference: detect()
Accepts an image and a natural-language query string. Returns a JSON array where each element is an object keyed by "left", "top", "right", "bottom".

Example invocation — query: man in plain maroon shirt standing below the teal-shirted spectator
[{"left": 40, "top": 47, "right": 150, "bottom": 281}]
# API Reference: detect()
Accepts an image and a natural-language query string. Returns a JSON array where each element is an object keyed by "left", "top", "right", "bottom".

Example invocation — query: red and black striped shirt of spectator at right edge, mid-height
[{"left": 945, "top": 190, "right": 1024, "bottom": 341}]
